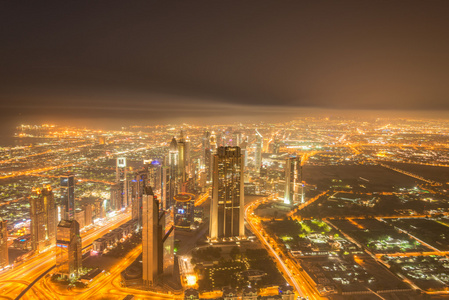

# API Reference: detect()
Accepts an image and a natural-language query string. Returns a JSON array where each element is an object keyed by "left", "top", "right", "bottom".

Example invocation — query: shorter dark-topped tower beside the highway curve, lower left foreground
[{"left": 56, "top": 220, "right": 82, "bottom": 278}]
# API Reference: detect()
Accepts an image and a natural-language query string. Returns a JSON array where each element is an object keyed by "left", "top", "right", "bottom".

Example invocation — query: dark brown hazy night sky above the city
[{"left": 0, "top": 0, "right": 449, "bottom": 126}]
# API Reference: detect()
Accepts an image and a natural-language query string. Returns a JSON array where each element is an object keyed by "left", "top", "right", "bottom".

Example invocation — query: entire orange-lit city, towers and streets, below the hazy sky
[{"left": 0, "top": 116, "right": 449, "bottom": 300}]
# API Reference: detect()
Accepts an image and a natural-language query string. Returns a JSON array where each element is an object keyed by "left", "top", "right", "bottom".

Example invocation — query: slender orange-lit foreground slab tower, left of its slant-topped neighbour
[{"left": 142, "top": 187, "right": 161, "bottom": 286}]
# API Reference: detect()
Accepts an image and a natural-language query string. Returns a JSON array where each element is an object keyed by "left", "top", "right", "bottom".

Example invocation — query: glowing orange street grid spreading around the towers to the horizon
[{"left": 0, "top": 118, "right": 449, "bottom": 299}]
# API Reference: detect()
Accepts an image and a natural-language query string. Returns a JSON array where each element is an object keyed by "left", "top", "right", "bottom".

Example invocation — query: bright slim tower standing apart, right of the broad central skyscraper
[{"left": 284, "top": 156, "right": 302, "bottom": 204}]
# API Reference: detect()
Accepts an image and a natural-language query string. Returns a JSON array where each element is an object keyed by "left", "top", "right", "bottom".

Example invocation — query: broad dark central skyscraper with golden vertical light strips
[{"left": 209, "top": 147, "right": 245, "bottom": 240}]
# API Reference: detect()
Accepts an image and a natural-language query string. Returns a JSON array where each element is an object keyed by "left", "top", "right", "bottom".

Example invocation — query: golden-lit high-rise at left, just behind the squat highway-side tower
[{"left": 30, "top": 186, "right": 56, "bottom": 252}]
